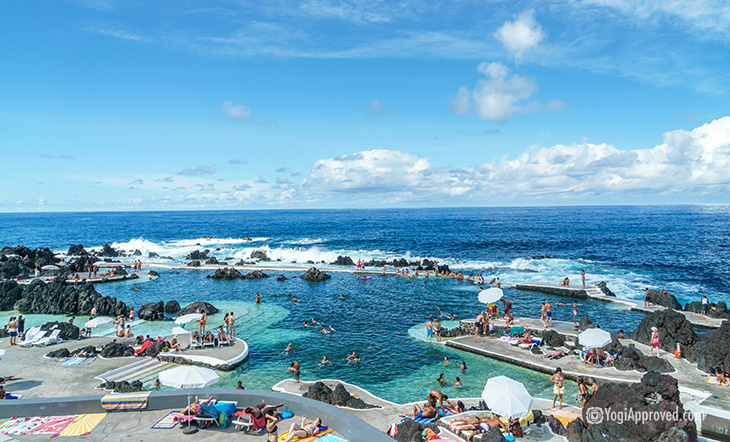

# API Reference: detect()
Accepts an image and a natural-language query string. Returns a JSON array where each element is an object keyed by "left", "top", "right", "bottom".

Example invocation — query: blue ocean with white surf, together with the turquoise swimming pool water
[{"left": 0, "top": 206, "right": 730, "bottom": 402}]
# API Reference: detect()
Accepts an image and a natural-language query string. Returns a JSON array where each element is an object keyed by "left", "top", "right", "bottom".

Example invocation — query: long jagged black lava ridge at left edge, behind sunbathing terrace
[{"left": 9, "top": 277, "right": 129, "bottom": 316}]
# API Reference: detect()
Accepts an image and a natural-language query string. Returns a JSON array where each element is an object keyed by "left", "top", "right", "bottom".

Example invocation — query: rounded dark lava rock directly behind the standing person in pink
[{"left": 629, "top": 310, "right": 697, "bottom": 353}]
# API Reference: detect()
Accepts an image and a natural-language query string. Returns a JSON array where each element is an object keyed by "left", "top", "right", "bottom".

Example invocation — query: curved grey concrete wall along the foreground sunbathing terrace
[{"left": 0, "top": 389, "right": 393, "bottom": 442}]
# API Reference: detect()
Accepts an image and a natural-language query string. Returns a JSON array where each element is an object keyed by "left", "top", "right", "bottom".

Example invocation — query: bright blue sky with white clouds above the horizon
[{"left": 0, "top": 0, "right": 730, "bottom": 212}]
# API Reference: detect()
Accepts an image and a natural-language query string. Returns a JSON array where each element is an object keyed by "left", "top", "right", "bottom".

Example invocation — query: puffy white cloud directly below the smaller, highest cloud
[{"left": 451, "top": 62, "right": 565, "bottom": 123}]
